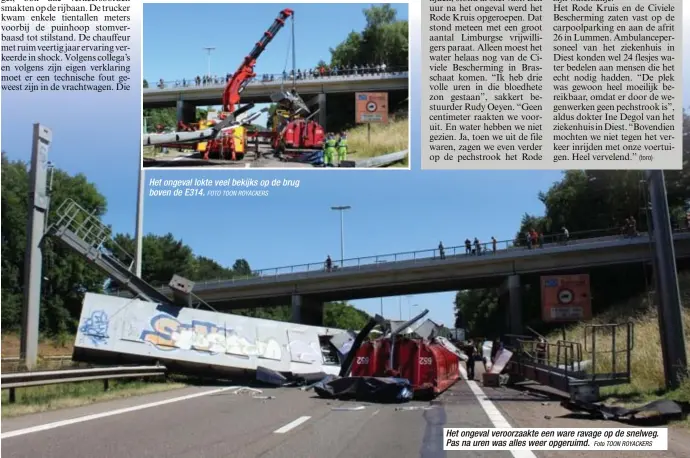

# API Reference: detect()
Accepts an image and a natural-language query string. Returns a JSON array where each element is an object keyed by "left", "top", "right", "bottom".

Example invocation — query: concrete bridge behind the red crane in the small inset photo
[{"left": 143, "top": 69, "right": 409, "bottom": 130}]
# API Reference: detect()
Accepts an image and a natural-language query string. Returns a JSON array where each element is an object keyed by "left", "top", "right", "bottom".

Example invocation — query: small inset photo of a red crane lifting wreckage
[{"left": 142, "top": 3, "right": 410, "bottom": 169}]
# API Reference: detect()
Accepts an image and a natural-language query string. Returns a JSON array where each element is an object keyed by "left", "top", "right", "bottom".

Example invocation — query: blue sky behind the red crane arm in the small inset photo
[{"left": 144, "top": 3, "right": 408, "bottom": 82}]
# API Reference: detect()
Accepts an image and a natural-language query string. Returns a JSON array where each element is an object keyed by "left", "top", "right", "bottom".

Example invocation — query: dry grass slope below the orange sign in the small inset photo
[{"left": 347, "top": 119, "right": 410, "bottom": 163}]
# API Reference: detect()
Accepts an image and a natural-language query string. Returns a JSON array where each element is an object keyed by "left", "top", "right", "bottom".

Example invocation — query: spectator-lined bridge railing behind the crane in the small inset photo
[{"left": 144, "top": 67, "right": 408, "bottom": 92}]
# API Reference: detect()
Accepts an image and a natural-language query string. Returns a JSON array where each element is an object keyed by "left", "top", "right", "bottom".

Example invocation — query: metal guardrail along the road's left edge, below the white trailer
[{"left": 0, "top": 366, "right": 167, "bottom": 403}]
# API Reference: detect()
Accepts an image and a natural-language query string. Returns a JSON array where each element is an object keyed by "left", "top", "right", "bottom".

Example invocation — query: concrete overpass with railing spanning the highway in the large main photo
[{"left": 138, "top": 231, "right": 690, "bottom": 328}]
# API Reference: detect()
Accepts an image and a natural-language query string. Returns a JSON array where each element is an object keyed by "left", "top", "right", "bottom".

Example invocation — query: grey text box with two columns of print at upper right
[{"left": 422, "top": 0, "right": 682, "bottom": 170}]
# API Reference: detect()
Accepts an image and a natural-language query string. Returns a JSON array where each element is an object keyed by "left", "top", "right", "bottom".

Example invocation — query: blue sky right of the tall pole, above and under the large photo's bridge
[{"left": 145, "top": 170, "right": 560, "bottom": 325}]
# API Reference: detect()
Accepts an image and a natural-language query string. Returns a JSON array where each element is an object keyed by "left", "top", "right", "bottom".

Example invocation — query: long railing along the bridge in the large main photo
[{"left": 196, "top": 228, "right": 644, "bottom": 286}]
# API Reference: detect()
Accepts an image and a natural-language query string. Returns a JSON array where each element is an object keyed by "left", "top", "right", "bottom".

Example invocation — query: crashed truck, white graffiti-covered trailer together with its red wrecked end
[{"left": 73, "top": 292, "right": 466, "bottom": 401}]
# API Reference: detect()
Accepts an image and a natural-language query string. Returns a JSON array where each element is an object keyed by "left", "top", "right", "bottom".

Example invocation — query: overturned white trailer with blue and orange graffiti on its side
[{"left": 73, "top": 293, "right": 343, "bottom": 378}]
